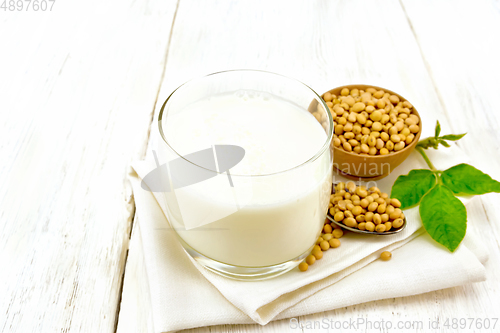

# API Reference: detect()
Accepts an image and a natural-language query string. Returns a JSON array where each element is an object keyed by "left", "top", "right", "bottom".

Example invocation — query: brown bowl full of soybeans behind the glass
[{"left": 322, "top": 84, "right": 422, "bottom": 180}]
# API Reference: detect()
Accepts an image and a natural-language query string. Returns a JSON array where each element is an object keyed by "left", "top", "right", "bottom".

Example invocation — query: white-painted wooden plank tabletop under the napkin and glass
[{"left": 0, "top": 0, "right": 500, "bottom": 333}]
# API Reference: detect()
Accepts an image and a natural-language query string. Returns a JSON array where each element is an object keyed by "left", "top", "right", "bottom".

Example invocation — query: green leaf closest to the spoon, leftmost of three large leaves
[{"left": 391, "top": 169, "right": 436, "bottom": 209}]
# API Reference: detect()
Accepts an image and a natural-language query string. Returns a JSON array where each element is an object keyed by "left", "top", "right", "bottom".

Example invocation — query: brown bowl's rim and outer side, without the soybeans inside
[{"left": 321, "top": 84, "right": 422, "bottom": 181}]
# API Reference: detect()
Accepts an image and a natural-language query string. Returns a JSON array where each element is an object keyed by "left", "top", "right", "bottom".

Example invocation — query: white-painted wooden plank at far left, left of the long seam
[{"left": 0, "top": 0, "right": 176, "bottom": 332}]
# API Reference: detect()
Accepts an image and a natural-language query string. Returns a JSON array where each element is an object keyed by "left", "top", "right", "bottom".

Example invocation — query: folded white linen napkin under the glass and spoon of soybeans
[{"left": 131, "top": 146, "right": 487, "bottom": 332}]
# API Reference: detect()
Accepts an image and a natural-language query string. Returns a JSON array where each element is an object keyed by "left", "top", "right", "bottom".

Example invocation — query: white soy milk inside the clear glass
[{"left": 164, "top": 91, "right": 332, "bottom": 266}]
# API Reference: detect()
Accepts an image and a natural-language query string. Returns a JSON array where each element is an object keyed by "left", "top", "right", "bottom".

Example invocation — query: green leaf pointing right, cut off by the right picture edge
[{"left": 441, "top": 164, "right": 500, "bottom": 194}]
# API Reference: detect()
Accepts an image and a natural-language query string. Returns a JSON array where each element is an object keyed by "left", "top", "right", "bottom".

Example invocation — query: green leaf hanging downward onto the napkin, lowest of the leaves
[{"left": 419, "top": 184, "right": 467, "bottom": 252}]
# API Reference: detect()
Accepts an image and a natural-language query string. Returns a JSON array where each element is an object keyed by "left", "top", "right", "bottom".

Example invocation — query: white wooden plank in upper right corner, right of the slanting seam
[{"left": 402, "top": 0, "right": 500, "bottom": 176}]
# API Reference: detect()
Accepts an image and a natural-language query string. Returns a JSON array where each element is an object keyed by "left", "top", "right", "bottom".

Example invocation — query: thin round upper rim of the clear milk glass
[{"left": 157, "top": 69, "right": 333, "bottom": 177}]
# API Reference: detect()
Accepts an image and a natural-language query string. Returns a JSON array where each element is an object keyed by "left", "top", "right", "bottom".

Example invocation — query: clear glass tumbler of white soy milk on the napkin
[{"left": 157, "top": 70, "right": 333, "bottom": 280}]
